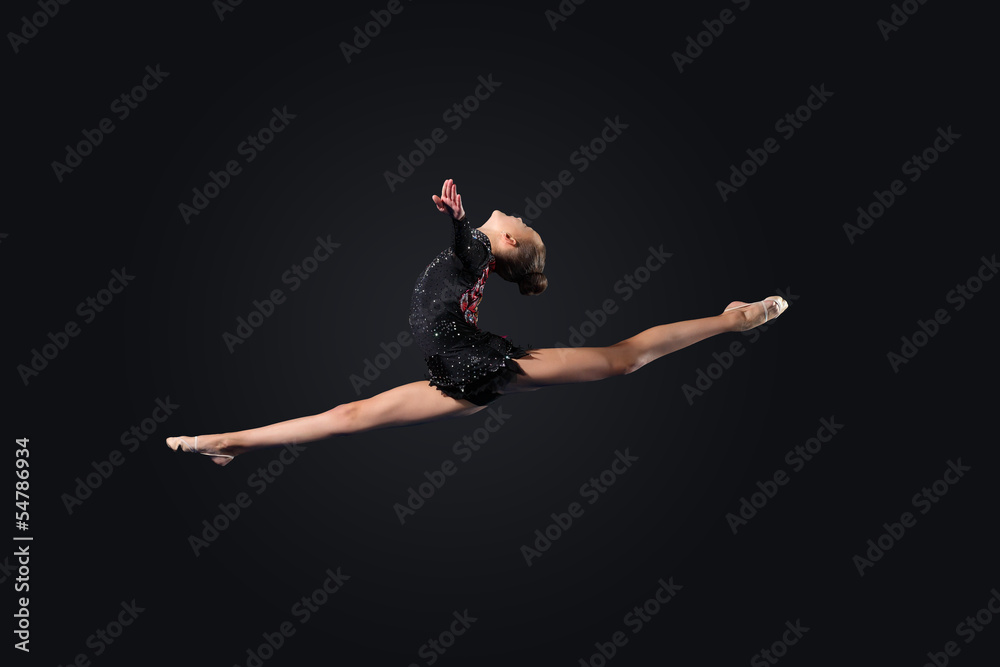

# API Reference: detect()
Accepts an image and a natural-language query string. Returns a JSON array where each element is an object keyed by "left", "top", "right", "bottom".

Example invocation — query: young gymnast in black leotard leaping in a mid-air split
[{"left": 167, "top": 179, "right": 788, "bottom": 465}]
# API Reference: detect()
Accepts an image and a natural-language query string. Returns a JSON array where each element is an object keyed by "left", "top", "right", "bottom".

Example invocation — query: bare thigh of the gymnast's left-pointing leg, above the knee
[{"left": 351, "top": 380, "right": 485, "bottom": 431}]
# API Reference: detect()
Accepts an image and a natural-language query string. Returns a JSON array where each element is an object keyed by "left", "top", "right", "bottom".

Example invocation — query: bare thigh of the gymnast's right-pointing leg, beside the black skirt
[{"left": 503, "top": 345, "right": 628, "bottom": 394}]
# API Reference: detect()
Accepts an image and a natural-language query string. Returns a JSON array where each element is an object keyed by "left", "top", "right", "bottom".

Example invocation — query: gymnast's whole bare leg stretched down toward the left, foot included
[{"left": 167, "top": 381, "right": 485, "bottom": 465}]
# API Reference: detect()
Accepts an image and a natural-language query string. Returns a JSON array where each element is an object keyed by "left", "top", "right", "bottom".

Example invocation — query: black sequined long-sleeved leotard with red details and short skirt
[{"left": 410, "top": 218, "right": 530, "bottom": 405}]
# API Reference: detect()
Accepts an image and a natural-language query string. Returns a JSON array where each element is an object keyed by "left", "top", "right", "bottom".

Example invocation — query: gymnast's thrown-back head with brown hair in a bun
[{"left": 483, "top": 211, "right": 549, "bottom": 296}]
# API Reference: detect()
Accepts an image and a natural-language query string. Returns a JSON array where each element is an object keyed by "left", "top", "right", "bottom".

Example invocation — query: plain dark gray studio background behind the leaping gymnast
[{"left": 0, "top": 0, "right": 1000, "bottom": 666}]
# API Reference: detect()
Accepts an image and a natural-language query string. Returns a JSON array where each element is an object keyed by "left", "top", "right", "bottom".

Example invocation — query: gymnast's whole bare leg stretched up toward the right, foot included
[{"left": 504, "top": 297, "right": 788, "bottom": 394}]
